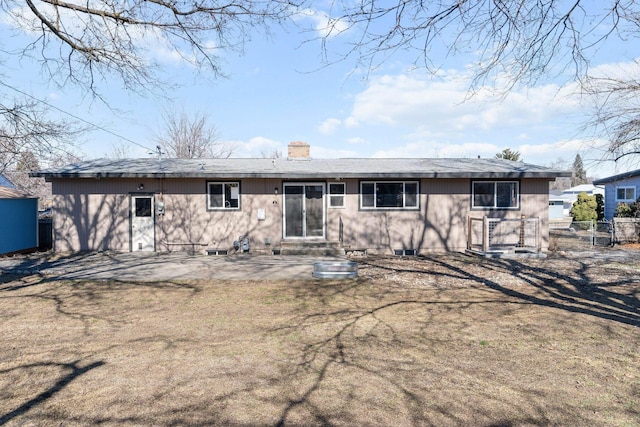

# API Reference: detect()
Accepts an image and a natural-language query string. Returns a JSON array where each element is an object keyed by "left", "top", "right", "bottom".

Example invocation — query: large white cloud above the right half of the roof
[{"left": 343, "top": 72, "right": 579, "bottom": 135}]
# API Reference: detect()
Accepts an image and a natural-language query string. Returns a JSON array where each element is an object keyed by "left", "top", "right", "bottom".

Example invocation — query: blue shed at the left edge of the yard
[{"left": 0, "top": 174, "right": 38, "bottom": 255}]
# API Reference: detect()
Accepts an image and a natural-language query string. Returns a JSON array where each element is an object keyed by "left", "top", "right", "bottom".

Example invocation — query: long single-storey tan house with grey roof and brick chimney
[{"left": 32, "top": 143, "right": 571, "bottom": 253}]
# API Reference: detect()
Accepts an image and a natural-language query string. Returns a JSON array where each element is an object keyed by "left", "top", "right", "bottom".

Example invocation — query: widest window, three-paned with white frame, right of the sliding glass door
[{"left": 360, "top": 181, "right": 419, "bottom": 209}]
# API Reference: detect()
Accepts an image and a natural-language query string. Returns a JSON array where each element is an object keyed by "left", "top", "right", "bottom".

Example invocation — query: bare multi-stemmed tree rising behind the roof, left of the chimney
[{"left": 156, "top": 111, "right": 235, "bottom": 159}]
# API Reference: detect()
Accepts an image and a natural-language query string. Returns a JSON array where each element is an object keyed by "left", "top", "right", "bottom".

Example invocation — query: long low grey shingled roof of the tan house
[{"left": 29, "top": 158, "right": 571, "bottom": 180}]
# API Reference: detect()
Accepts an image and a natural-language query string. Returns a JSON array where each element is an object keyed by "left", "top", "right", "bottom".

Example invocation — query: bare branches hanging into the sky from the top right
[{"left": 324, "top": 0, "right": 640, "bottom": 89}]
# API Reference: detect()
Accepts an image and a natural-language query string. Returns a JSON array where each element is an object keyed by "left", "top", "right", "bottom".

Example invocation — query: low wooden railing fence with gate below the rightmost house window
[{"left": 467, "top": 216, "right": 541, "bottom": 253}]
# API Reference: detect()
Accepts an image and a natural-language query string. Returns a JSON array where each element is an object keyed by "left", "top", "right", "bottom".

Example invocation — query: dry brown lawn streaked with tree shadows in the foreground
[{"left": 0, "top": 255, "right": 640, "bottom": 426}]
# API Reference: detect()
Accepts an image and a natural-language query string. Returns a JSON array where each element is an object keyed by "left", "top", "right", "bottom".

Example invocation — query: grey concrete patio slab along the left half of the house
[{"left": 0, "top": 252, "right": 344, "bottom": 281}]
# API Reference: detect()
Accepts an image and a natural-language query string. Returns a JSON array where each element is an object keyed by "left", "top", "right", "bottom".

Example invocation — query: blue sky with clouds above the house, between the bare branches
[{"left": 0, "top": 3, "right": 637, "bottom": 177}]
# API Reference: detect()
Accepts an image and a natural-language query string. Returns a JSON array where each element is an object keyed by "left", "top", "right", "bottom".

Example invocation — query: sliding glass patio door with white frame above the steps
[{"left": 283, "top": 183, "right": 325, "bottom": 239}]
